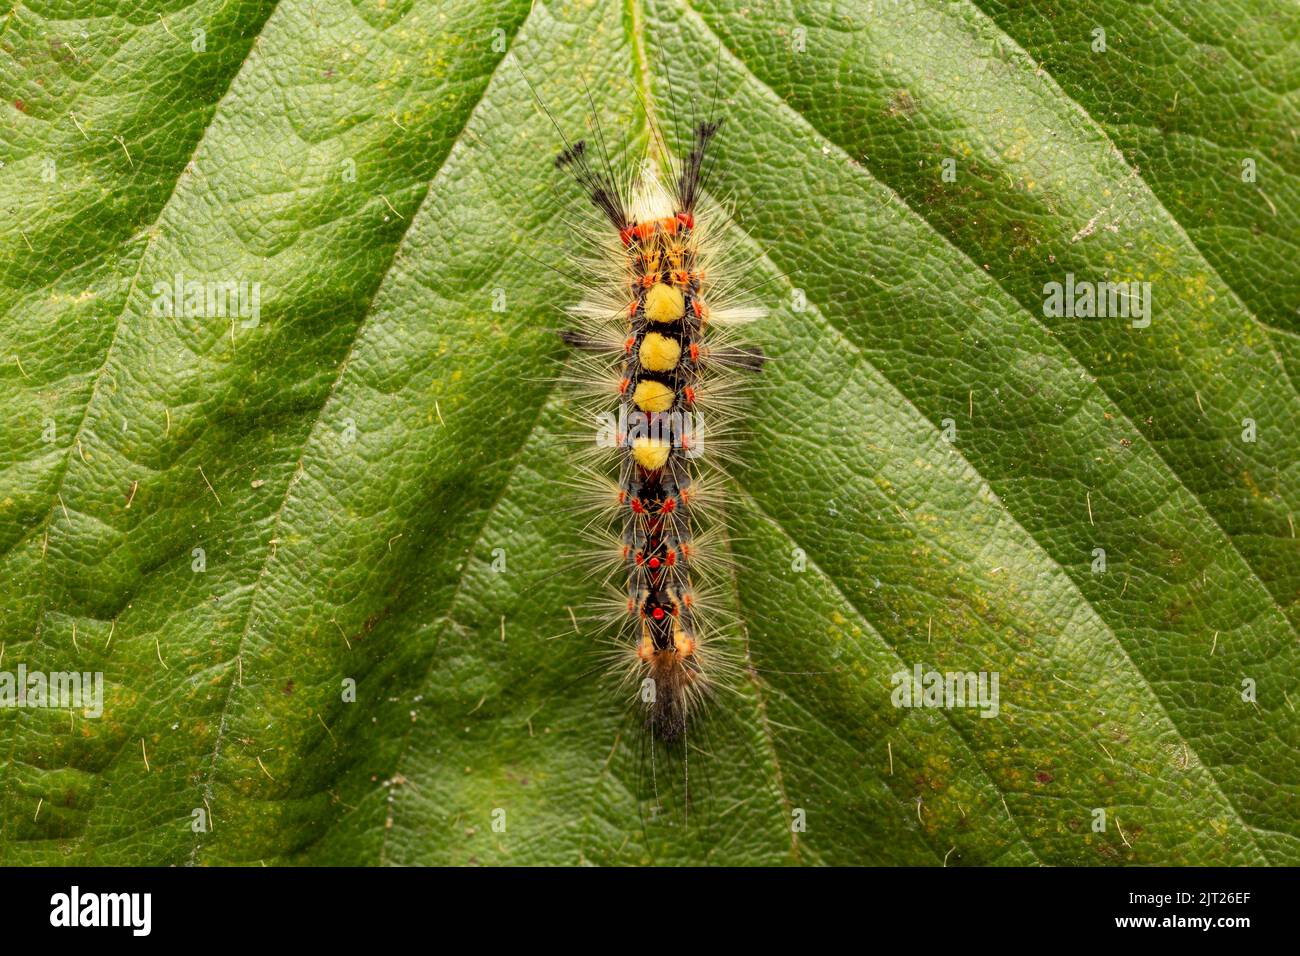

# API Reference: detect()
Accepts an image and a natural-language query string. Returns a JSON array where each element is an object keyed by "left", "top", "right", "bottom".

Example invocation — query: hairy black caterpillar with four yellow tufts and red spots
[{"left": 534, "top": 76, "right": 764, "bottom": 786}]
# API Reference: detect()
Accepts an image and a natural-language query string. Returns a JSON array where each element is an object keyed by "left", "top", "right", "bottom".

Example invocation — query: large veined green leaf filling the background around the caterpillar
[{"left": 0, "top": 0, "right": 1300, "bottom": 865}]
